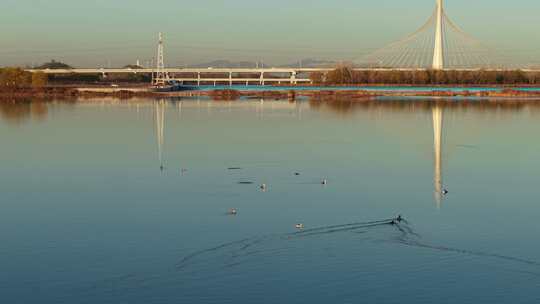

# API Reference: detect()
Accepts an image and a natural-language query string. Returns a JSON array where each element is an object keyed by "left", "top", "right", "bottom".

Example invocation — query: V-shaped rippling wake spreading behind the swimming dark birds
[{"left": 84, "top": 219, "right": 540, "bottom": 291}]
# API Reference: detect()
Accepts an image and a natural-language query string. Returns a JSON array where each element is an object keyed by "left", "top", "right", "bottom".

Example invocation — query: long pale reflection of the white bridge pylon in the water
[{"left": 432, "top": 105, "right": 443, "bottom": 208}]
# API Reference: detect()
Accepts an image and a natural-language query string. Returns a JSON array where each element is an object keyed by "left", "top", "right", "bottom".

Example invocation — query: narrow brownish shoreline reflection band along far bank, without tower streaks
[{"left": 0, "top": 96, "right": 540, "bottom": 123}]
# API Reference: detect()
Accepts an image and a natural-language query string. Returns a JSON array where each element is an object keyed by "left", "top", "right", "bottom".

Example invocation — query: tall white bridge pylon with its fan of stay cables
[{"left": 355, "top": 0, "right": 511, "bottom": 70}]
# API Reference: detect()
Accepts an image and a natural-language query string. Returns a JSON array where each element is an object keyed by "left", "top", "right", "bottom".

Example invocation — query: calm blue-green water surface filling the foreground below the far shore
[{"left": 0, "top": 99, "right": 540, "bottom": 304}]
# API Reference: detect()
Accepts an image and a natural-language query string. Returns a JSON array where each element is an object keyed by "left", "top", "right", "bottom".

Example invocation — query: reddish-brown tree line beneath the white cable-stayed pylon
[{"left": 310, "top": 66, "right": 540, "bottom": 85}]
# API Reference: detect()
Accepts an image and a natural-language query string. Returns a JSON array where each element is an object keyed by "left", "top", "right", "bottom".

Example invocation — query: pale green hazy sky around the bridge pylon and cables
[{"left": 0, "top": 0, "right": 540, "bottom": 67}]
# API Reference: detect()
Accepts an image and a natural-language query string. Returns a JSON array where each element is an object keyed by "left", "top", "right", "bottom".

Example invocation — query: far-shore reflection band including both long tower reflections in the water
[{"left": 0, "top": 96, "right": 540, "bottom": 208}]
